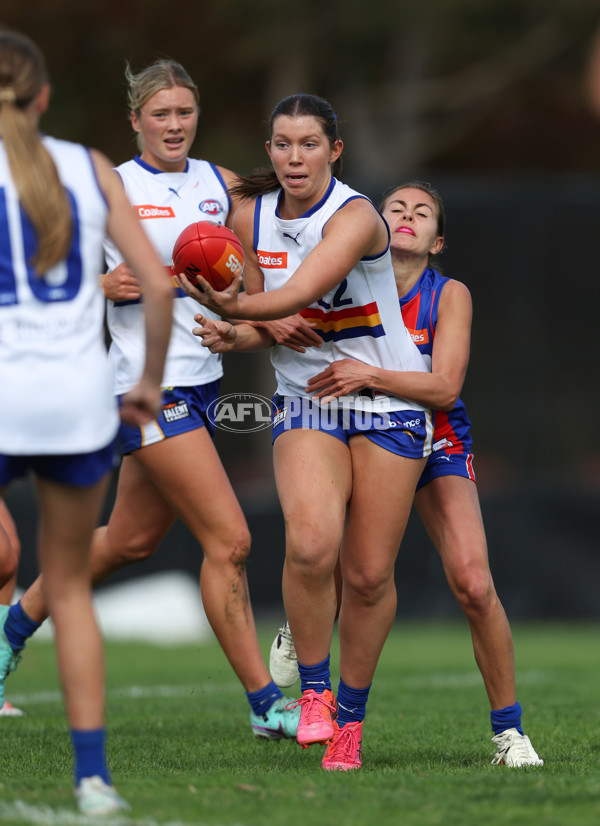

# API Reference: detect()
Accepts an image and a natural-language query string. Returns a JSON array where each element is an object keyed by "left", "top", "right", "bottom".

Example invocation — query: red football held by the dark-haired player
[{"left": 173, "top": 221, "right": 244, "bottom": 291}]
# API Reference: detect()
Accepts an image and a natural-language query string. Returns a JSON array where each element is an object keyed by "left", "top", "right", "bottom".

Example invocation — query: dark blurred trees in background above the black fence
[{"left": 2, "top": 0, "right": 600, "bottom": 181}]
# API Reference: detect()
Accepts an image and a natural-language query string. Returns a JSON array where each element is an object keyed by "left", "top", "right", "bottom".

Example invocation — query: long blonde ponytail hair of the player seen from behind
[{"left": 0, "top": 31, "right": 73, "bottom": 274}]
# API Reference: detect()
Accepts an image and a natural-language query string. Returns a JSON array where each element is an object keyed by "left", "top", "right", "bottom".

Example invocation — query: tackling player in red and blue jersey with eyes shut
[{"left": 271, "top": 181, "right": 543, "bottom": 767}]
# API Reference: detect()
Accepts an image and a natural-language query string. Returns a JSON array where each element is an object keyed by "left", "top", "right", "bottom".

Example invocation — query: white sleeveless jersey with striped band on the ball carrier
[{"left": 253, "top": 178, "right": 428, "bottom": 411}]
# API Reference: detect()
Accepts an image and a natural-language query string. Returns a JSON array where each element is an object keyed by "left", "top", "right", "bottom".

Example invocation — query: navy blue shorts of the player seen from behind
[{"left": 0, "top": 440, "right": 118, "bottom": 488}]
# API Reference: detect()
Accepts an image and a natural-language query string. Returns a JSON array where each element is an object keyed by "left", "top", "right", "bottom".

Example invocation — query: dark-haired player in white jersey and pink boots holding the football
[{"left": 176, "top": 95, "right": 432, "bottom": 770}]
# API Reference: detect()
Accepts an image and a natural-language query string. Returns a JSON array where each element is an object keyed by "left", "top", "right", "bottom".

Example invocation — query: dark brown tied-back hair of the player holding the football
[{"left": 229, "top": 94, "right": 342, "bottom": 198}]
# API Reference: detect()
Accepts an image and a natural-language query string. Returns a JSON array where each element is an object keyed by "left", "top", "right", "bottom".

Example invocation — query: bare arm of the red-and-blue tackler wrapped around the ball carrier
[{"left": 306, "top": 281, "right": 473, "bottom": 410}]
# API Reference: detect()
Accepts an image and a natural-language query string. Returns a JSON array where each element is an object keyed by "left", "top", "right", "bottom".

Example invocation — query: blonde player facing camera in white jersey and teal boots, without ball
[{"left": 0, "top": 60, "right": 299, "bottom": 739}]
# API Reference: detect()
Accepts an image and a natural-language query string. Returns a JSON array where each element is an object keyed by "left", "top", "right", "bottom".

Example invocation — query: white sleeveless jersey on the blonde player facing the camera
[{"left": 105, "top": 157, "right": 231, "bottom": 394}]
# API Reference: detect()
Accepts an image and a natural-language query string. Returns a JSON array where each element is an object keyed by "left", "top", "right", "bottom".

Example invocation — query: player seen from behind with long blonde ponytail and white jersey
[{"left": 0, "top": 31, "right": 172, "bottom": 815}]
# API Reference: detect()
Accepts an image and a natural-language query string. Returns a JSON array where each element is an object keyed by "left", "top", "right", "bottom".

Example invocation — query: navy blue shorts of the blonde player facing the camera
[{"left": 119, "top": 379, "right": 221, "bottom": 456}]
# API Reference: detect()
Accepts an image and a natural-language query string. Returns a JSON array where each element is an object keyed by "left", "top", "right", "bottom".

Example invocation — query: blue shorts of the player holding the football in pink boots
[{"left": 272, "top": 393, "right": 433, "bottom": 459}]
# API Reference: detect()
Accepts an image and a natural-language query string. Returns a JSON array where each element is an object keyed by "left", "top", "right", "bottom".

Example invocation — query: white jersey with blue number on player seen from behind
[{"left": 0, "top": 137, "right": 119, "bottom": 455}]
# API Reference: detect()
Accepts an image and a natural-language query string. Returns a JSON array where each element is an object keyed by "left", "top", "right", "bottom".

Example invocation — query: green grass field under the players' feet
[{"left": 0, "top": 623, "right": 600, "bottom": 826}]
